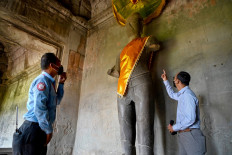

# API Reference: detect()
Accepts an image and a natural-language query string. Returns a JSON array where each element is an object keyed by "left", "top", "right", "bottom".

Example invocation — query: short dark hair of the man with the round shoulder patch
[{"left": 41, "top": 53, "right": 57, "bottom": 70}]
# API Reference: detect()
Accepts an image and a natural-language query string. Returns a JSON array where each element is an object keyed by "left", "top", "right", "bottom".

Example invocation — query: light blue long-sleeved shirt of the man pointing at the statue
[{"left": 164, "top": 80, "right": 200, "bottom": 131}]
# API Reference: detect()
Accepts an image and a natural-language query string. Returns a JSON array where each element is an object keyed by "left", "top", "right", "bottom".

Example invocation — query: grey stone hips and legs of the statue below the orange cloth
[{"left": 117, "top": 74, "right": 154, "bottom": 155}]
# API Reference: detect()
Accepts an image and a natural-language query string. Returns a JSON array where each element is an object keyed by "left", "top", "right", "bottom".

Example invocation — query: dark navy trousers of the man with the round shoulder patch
[{"left": 12, "top": 121, "right": 47, "bottom": 155}]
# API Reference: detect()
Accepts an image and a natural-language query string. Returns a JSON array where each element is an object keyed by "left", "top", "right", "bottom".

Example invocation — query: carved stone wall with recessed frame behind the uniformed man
[{"left": 0, "top": 0, "right": 87, "bottom": 155}]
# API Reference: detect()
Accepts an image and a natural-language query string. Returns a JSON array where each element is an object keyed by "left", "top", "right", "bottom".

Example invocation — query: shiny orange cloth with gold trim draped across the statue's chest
[{"left": 117, "top": 37, "right": 149, "bottom": 97}]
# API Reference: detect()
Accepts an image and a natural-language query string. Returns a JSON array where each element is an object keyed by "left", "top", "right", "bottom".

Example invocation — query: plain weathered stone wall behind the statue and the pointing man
[{"left": 73, "top": 0, "right": 232, "bottom": 155}]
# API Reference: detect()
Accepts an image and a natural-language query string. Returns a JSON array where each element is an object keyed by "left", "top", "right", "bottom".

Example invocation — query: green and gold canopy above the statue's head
[{"left": 112, "top": 0, "right": 165, "bottom": 26}]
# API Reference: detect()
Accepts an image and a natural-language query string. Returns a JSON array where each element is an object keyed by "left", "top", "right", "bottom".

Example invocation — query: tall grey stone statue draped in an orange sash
[{"left": 107, "top": 13, "right": 160, "bottom": 155}]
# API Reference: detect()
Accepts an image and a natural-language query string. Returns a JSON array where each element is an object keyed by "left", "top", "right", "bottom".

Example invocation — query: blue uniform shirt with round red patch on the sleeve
[{"left": 23, "top": 72, "right": 64, "bottom": 134}]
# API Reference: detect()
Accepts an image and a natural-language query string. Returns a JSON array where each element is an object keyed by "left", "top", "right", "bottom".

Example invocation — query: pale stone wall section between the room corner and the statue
[{"left": 73, "top": 14, "right": 128, "bottom": 155}]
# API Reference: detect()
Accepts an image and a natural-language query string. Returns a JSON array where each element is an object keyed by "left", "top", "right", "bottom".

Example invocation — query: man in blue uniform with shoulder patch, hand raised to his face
[{"left": 12, "top": 53, "right": 67, "bottom": 155}]
